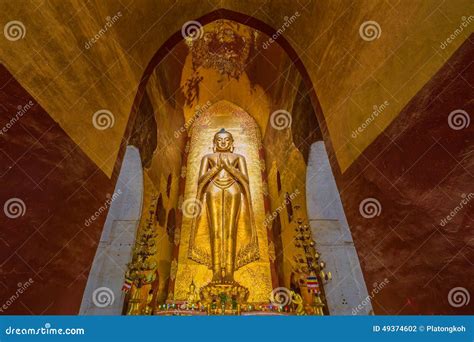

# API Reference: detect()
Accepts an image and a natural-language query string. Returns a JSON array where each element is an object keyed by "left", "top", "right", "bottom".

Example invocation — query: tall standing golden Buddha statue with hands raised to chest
[{"left": 188, "top": 128, "right": 259, "bottom": 284}]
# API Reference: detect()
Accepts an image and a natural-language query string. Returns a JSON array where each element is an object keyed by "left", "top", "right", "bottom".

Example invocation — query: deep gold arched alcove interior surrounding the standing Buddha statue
[{"left": 80, "top": 19, "right": 366, "bottom": 314}]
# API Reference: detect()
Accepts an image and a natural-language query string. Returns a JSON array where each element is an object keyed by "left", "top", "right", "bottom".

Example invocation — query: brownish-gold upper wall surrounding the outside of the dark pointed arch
[{"left": 0, "top": 0, "right": 474, "bottom": 176}]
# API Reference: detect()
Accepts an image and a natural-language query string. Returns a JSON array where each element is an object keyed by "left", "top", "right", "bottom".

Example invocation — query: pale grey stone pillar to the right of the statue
[{"left": 306, "top": 141, "right": 372, "bottom": 315}]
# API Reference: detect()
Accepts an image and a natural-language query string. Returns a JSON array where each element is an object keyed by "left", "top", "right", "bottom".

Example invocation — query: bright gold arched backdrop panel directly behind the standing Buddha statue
[{"left": 174, "top": 101, "right": 272, "bottom": 302}]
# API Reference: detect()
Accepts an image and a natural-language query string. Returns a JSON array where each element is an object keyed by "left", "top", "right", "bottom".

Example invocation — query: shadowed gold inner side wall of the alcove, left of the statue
[{"left": 129, "top": 56, "right": 185, "bottom": 304}]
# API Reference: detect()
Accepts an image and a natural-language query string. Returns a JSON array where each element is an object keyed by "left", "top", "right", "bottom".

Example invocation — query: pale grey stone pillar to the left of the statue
[{"left": 79, "top": 146, "right": 143, "bottom": 315}]
